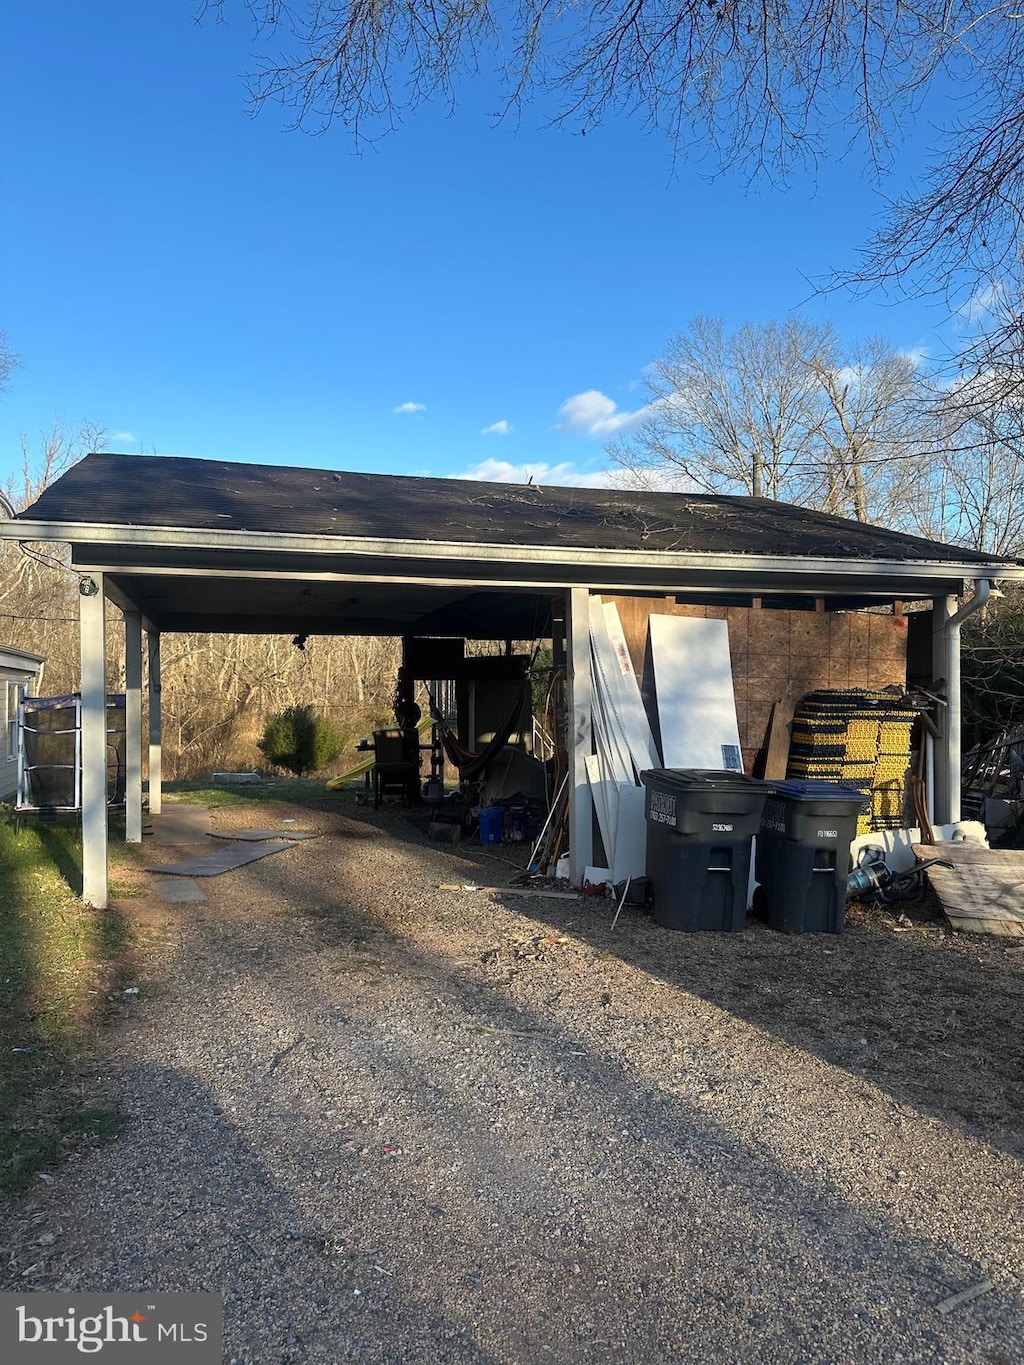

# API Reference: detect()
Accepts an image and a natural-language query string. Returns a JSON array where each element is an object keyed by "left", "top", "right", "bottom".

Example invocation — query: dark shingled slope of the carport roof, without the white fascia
[{"left": 22, "top": 455, "right": 1009, "bottom": 564}]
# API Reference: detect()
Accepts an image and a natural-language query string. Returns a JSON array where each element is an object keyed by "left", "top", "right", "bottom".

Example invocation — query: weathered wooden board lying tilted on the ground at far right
[{"left": 913, "top": 844, "right": 1024, "bottom": 938}]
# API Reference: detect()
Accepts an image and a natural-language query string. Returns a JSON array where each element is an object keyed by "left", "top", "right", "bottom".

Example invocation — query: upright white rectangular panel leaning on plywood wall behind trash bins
[{"left": 649, "top": 616, "right": 743, "bottom": 773}]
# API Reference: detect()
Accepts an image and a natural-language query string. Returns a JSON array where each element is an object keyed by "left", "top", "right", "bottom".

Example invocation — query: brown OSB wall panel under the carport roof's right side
[{"left": 603, "top": 595, "right": 907, "bottom": 770}]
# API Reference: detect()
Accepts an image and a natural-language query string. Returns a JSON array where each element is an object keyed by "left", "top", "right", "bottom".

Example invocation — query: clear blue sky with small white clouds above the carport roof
[{"left": 0, "top": 0, "right": 972, "bottom": 483}]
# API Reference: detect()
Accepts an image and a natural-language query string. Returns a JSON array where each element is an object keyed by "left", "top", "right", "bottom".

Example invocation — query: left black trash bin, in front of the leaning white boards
[{"left": 640, "top": 768, "right": 769, "bottom": 932}]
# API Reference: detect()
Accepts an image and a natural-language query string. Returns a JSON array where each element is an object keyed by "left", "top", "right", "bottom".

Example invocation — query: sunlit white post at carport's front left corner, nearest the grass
[{"left": 78, "top": 573, "right": 106, "bottom": 910}]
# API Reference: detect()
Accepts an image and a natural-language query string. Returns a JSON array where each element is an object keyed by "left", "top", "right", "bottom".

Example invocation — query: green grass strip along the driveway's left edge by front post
[{"left": 0, "top": 820, "right": 137, "bottom": 1190}]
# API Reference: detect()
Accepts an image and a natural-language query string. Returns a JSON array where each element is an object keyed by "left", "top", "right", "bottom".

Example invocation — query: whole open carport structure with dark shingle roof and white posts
[{"left": 0, "top": 455, "right": 1024, "bottom": 906}]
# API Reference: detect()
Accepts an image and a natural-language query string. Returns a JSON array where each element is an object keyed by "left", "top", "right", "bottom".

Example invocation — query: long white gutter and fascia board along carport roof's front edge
[{"left": 0, "top": 520, "right": 1024, "bottom": 583}]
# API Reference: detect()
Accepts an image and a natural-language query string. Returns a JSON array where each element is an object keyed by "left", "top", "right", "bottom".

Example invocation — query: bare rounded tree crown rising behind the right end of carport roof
[{"left": 610, "top": 317, "right": 931, "bottom": 518}]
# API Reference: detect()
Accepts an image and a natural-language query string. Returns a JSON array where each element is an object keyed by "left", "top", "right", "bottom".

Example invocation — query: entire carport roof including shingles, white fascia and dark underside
[{"left": 10, "top": 455, "right": 1024, "bottom": 639}]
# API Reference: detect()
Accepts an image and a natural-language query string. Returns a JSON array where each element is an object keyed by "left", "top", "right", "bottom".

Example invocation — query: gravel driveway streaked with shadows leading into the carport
[{"left": 0, "top": 805, "right": 1024, "bottom": 1365}]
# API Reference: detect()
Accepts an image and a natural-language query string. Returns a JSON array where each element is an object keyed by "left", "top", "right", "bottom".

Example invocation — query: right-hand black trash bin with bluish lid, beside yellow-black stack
[{"left": 754, "top": 781, "right": 870, "bottom": 934}]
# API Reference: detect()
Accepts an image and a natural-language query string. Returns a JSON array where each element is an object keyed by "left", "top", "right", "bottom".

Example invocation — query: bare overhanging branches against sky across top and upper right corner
[{"left": 202, "top": 0, "right": 1024, "bottom": 298}]
